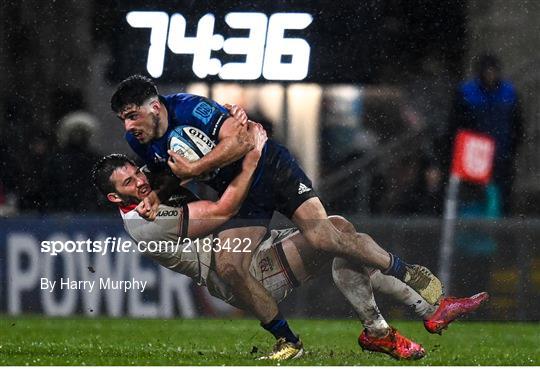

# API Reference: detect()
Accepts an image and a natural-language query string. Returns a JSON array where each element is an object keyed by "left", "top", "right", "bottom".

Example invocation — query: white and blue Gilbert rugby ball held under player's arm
[{"left": 168, "top": 126, "right": 216, "bottom": 161}]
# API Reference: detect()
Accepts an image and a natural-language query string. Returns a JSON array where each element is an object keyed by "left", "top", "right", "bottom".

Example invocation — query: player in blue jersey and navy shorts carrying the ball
[{"left": 111, "top": 75, "right": 442, "bottom": 360}]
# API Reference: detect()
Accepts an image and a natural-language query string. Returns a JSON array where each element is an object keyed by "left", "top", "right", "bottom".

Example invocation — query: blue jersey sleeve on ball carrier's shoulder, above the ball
[{"left": 168, "top": 94, "right": 229, "bottom": 142}]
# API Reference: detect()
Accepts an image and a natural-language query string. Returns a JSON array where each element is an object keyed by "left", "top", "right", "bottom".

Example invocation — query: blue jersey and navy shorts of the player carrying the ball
[{"left": 126, "top": 93, "right": 316, "bottom": 224}]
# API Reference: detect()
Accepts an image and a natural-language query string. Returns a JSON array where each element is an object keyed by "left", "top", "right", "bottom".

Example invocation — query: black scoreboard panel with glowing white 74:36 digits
[{"left": 108, "top": 0, "right": 382, "bottom": 83}]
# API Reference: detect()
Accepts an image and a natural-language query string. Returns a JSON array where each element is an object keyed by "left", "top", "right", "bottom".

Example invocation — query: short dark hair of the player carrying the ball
[{"left": 111, "top": 74, "right": 158, "bottom": 114}]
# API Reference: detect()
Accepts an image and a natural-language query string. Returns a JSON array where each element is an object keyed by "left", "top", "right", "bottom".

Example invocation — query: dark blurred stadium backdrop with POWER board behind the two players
[{"left": 0, "top": 0, "right": 540, "bottom": 320}]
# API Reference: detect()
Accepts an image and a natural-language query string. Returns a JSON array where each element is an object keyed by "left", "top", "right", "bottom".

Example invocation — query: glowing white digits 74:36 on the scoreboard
[{"left": 126, "top": 11, "right": 313, "bottom": 81}]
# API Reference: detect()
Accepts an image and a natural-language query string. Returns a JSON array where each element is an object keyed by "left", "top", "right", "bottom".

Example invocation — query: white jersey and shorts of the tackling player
[{"left": 120, "top": 204, "right": 298, "bottom": 307}]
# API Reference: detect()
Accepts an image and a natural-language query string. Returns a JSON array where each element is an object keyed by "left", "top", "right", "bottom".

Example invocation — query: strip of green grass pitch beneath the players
[{"left": 0, "top": 316, "right": 540, "bottom": 366}]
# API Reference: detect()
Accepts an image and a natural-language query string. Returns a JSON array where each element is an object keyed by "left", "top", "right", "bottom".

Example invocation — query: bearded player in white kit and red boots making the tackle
[{"left": 90, "top": 128, "right": 487, "bottom": 359}]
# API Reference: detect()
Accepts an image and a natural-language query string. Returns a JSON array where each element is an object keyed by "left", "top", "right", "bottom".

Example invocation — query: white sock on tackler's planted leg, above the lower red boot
[{"left": 332, "top": 258, "right": 390, "bottom": 337}]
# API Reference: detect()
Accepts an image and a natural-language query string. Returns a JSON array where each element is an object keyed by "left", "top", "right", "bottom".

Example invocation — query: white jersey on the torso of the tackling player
[{"left": 120, "top": 204, "right": 212, "bottom": 285}]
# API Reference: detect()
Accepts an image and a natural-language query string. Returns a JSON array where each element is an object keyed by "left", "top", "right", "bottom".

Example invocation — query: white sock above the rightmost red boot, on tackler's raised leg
[{"left": 369, "top": 269, "right": 437, "bottom": 318}]
